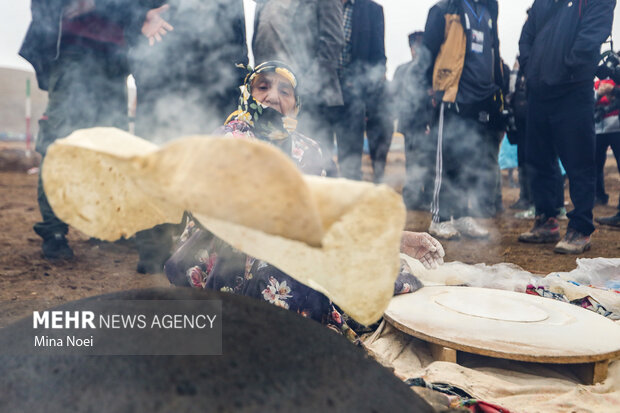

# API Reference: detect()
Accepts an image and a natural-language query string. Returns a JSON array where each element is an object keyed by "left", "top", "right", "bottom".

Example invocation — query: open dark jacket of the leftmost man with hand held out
[{"left": 19, "top": 0, "right": 148, "bottom": 90}]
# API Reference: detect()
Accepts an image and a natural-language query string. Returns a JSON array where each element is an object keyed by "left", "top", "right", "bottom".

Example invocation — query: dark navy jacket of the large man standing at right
[{"left": 519, "top": 0, "right": 616, "bottom": 94}]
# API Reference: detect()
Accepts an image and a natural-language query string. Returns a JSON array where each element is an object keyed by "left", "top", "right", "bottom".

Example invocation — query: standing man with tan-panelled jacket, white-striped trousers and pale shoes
[{"left": 424, "top": 0, "right": 504, "bottom": 239}]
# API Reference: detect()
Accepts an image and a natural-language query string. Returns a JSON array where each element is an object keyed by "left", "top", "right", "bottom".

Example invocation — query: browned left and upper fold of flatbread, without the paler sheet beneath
[{"left": 42, "top": 128, "right": 323, "bottom": 245}]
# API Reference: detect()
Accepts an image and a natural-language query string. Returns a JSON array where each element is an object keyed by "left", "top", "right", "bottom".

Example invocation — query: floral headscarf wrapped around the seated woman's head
[{"left": 225, "top": 61, "right": 301, "bottom": 140}]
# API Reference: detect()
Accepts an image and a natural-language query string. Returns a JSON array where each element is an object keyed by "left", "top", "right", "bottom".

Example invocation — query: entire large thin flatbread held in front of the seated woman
[{"left": 42, "top": 128, "right": 405, "bottom": 324}]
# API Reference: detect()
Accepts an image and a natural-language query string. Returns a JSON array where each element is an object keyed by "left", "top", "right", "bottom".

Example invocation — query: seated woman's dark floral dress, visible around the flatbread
[{"left": 165, "top": 120, "right": 421, "bottom": 344}]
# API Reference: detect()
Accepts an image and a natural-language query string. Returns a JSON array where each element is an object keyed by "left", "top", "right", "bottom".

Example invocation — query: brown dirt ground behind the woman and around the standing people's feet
[{"left": 0, "top": 142, "right": 620, "bottom": 327}]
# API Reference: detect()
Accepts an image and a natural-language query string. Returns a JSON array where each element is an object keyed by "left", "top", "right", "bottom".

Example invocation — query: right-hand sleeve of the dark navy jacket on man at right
[{"left": 566, "top": 0, "right": 616, "bottom": 67}]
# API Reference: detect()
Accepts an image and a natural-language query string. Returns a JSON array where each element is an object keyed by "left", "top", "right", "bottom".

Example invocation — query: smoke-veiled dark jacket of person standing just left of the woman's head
[{"left": 129, "top": 0, "right": 248, "bottom": 89}]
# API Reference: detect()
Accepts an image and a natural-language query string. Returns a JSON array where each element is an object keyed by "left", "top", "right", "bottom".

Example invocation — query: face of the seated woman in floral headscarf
[{"left": 252, "top": 72, "right": 296, "bottom": 117}]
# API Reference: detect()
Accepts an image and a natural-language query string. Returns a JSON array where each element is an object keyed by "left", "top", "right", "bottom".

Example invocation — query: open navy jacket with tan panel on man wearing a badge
[{"left": 423, "top": 0, "right": 504, "bottom": 102}]
